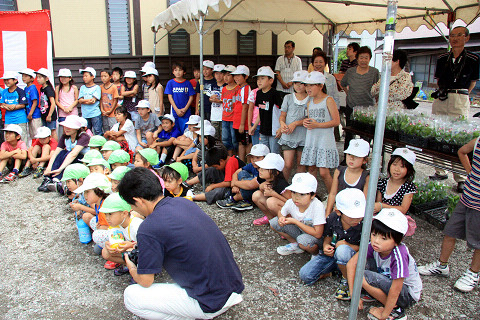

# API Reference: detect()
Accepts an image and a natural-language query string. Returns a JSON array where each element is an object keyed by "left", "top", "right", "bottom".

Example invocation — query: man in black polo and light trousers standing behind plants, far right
[{"left": 430, "top": 26, "right": 479, "bottom": 192}]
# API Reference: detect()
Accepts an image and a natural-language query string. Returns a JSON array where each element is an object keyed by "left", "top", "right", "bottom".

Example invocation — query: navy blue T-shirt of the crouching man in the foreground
[{"left": 137, "top": 197, "right": 244, "bottom": 313}]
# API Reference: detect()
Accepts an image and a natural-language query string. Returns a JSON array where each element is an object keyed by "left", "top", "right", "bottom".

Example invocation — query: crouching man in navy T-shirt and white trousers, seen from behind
[{"left": 118, "top": 168, "right": 244, "bottom": 319}]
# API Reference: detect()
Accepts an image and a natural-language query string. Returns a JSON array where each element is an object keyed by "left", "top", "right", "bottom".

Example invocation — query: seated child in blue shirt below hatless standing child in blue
[{"left": 149, "top": 114, "right": 181, "bottom": 168}]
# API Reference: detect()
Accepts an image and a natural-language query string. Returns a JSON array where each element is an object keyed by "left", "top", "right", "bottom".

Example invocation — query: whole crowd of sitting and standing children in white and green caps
[{"left": 0, "top": 57, "right": 480, "bottom": 319}]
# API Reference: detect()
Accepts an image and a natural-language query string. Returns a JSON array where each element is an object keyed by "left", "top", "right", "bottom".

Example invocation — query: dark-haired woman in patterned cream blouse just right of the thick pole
[{"left": 371, "top": 50, "right": 413, "bottom": 110}]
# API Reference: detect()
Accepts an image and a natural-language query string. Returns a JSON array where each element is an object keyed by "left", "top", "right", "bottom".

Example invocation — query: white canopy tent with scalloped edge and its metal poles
[{"left": 152, "top": 0, "right": 480, "bottom": 320}]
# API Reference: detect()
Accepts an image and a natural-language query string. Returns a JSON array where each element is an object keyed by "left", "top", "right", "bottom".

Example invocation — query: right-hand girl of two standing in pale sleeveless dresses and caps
[{"left": 300, "top": 71, "right": 340, "bottom": 193}]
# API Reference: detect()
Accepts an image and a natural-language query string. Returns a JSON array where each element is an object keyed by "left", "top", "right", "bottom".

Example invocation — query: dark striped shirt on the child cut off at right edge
[{"left": 460, "top": 139, "right": 480, "bottom": 211}]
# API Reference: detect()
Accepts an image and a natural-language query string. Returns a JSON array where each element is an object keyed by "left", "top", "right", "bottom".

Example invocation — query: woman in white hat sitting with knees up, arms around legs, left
[{"left": 37, "top": 115, "right": 90, "bottom": 192}]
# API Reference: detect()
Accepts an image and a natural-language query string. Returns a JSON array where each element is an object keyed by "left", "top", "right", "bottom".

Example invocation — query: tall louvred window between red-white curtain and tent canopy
[{"left": 107, "top": 0, "right": 131, "bottom": 54}]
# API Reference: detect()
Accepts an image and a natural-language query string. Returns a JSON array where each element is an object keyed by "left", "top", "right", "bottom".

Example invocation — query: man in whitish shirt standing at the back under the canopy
[{"left": 275, "top": 40, "right": 302, "bottom": 93}]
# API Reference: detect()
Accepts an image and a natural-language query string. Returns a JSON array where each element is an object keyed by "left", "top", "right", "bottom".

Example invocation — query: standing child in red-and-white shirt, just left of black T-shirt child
[{"left": 232, "top": 65, "right": 252, "bottom": 160}]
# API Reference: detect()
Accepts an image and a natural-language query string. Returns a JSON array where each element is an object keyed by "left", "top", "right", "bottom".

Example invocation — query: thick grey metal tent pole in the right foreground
[{"left": 348, "top": 0, "right": 398, "bottom": 320}]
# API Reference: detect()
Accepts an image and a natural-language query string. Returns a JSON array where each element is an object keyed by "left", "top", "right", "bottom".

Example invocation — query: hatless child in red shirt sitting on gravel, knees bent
[{"left": 187, "top": 148, "right": 245, "bottom": 204}]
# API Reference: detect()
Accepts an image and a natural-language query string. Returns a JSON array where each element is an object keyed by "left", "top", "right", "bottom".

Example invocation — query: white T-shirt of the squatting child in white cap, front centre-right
[{"left": 280, "top": 198, "right": 326, "bottom": 227}]
